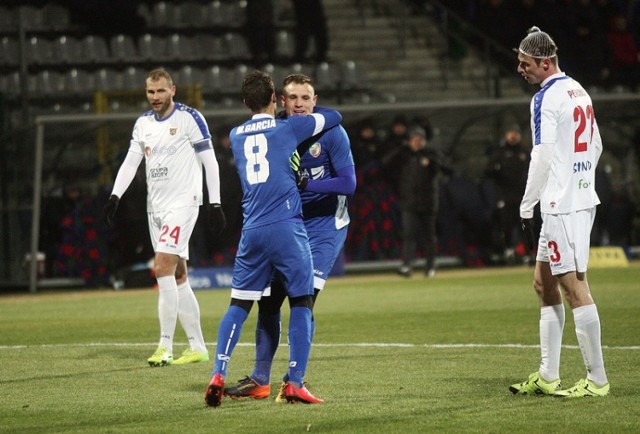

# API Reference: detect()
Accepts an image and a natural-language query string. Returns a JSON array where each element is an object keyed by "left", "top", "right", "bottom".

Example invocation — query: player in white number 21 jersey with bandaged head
[{"left": 509, "top": 27, "right": 609, "bottom": 398}]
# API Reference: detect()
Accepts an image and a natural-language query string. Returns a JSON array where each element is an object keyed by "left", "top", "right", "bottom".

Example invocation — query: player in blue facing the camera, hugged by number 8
[{"left": 224, "top": 74, "right": 356, "bottom": 402}]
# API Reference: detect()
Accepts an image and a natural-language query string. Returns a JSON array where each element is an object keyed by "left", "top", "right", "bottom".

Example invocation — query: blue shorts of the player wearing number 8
[{"left": 231, "top": 220, "right": 313, "bottom": 300}]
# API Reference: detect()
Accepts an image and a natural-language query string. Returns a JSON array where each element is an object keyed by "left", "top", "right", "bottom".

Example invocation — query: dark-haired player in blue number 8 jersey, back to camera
[{"left": 205, "top": 71, "right": 342, "bottom": 407}]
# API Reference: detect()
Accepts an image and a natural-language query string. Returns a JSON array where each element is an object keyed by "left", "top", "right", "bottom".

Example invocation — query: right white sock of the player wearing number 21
[{"left": 573, "top": 304, "right": 609, "bottom": 386}]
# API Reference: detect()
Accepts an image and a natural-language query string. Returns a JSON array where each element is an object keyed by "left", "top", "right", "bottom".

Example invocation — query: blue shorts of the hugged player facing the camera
[{"left": 309, "top": 226, "right": 348, "bottom": 290}]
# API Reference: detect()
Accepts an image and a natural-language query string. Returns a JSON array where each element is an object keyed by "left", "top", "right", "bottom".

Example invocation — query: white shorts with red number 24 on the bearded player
[{"left": 147, "top": 206, "right": 200, "bottom": 260}]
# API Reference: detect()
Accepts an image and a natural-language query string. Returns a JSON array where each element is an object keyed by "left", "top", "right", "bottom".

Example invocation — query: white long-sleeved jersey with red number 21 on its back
[{"left": 520, "top": 73, "right": 602, "bottom": 218}]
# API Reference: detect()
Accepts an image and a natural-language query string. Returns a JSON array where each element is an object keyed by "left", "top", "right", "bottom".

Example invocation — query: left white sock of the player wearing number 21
[{"left": 540, "top": 304, "right": 565, "bottom": 381}]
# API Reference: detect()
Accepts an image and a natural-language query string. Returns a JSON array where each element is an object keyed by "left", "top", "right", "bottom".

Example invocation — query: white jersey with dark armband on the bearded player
[{"left": 129, "top": 103, "right": 211, "bottom": 211}]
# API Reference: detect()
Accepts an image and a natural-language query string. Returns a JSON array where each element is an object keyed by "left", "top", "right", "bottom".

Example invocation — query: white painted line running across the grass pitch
[{"left": 0, "top": 342, "right": 640, "bottom": 351}]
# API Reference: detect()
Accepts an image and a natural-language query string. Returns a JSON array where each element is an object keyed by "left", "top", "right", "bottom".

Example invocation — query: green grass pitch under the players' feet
[{"left": 0, "top": 262, "right": 640, "bottom": 434}]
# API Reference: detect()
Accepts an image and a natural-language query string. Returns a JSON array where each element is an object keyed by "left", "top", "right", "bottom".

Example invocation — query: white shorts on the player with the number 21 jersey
[{"left": 536, "top": 207, "right": 596, "bottom": 276}]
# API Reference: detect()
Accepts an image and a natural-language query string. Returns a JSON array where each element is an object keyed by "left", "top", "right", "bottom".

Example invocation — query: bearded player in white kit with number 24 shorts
[{"left": 104, "top": 69, "right": 226, "bottom": 366}]
